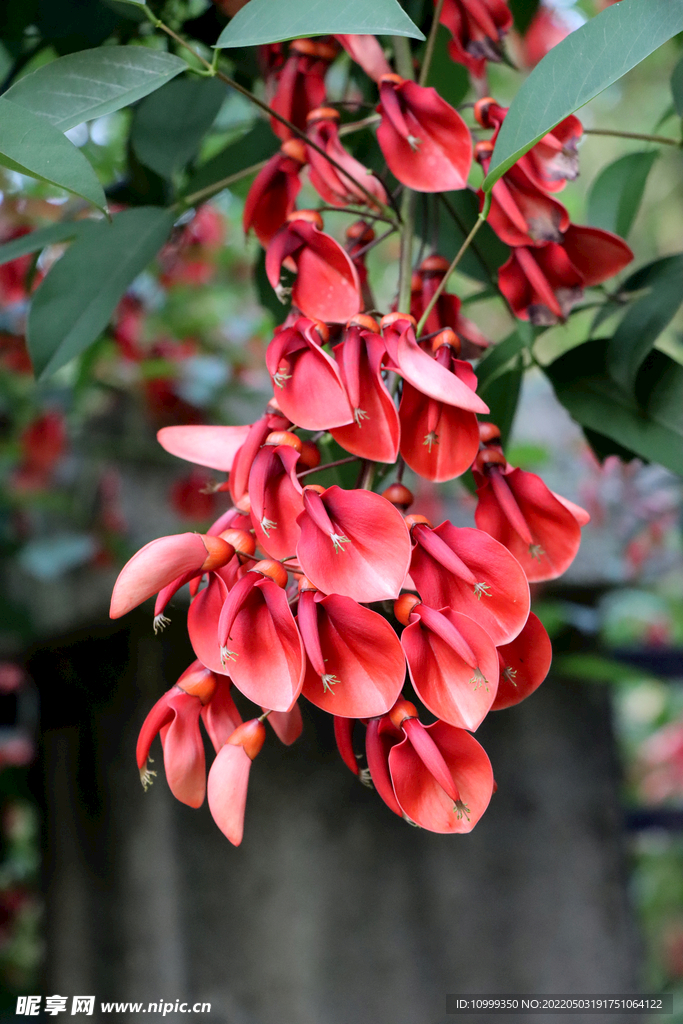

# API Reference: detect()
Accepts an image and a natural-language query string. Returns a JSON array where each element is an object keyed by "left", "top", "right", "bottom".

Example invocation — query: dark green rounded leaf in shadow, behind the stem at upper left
[{"left": 130, "top": 78, "right": 226, "bottom": 178}]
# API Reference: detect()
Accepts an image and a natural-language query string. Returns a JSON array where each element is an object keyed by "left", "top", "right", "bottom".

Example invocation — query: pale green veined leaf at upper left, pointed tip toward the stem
[{"left": 5, "top": 46, "right": 187, "bottom": 131}]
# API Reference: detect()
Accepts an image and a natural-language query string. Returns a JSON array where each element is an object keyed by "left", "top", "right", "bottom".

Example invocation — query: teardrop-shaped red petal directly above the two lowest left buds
[{"left": 227, "top": 577, "right": 305, "bottom": 711}]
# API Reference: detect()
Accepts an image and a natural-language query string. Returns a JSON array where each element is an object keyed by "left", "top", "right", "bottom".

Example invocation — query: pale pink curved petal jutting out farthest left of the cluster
[{"left": 110, "top": 534, "right": 209, "bottom": 618}]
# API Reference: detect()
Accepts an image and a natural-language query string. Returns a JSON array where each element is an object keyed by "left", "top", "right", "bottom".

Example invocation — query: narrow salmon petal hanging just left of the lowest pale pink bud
[{"left": 161, "top": 693, "right": 206, "bottom": 807}]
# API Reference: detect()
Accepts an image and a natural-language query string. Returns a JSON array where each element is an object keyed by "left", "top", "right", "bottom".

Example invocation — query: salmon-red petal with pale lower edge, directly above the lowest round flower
[{"left": 400, "top": 608, "right": 499, "bottom": 732}]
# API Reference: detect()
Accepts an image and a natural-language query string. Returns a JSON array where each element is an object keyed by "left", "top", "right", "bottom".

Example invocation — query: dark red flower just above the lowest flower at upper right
[{"left": 475, "top": 142, "right": 569, "bottom": 246}]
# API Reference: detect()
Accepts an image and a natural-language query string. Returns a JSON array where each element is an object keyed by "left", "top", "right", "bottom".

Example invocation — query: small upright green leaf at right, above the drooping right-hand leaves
[{"left": 588, "top": 151, "right": 658, "bottom": 239}]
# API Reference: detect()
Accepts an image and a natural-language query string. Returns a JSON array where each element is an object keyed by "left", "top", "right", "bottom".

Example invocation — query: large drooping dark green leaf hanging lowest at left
[{"left": 28, "top": 206, "right": 175, "bottom": 377}]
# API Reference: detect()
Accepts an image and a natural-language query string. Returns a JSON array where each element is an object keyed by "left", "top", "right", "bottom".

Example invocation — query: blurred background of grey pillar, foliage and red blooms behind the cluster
[{"left": 0, "top": 0, "right": 683, "bottom": 1024}]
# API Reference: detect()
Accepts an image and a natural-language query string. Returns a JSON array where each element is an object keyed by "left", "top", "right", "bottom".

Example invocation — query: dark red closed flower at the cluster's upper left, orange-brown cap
[{"left": 242, "top": 138, "right": 306, "bottom": 249}]
